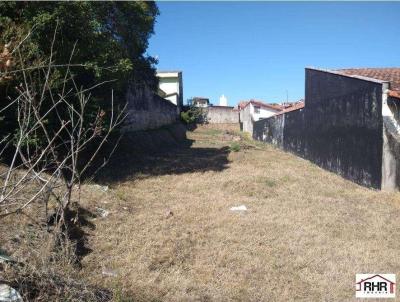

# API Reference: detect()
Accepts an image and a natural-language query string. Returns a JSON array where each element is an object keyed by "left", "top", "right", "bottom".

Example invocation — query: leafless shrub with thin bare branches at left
[{"left": 0, "top": 30, "right": 126, "bottom": 245}]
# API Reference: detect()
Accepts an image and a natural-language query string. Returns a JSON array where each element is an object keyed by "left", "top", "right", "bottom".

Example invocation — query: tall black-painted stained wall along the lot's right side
[{"left": 254, "top": 69, "right": 386, "bottom": 188}]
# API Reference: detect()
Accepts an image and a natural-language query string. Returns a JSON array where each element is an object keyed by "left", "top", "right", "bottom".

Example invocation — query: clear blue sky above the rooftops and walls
[{"left": 148, "top": 2, "right": 400, "bottom": 105}]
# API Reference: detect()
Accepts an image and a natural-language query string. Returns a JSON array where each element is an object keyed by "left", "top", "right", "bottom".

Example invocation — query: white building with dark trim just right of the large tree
[{"left": 157, "top": 71, "right": 183, "bottom": 108}]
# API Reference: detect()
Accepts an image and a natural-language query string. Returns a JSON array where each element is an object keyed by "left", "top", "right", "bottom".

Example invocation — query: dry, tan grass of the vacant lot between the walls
[{"left": 82, "top": 127, "right": 400, "bottom": 301}]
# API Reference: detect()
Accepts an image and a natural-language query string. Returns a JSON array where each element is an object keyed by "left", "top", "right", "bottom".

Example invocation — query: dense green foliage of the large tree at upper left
[{"left": 0, "top": 1, "right": 158, "bottom": 146}]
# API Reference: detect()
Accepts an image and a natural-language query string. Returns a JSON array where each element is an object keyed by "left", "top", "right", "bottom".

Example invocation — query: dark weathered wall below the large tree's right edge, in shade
[{"left": 124, "top": 88, "right": 178, "bottom": 131}]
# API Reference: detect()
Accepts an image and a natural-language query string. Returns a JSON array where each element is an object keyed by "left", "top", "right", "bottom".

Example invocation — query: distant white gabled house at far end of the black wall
[{"left": 238, "top": 99, "right": 284, "bottom": 133}]
